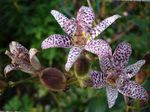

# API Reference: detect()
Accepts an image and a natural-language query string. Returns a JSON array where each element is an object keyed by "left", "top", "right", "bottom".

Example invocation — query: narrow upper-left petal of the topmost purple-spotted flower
[{"left": 51, "top": 10, "right": 76, "bottom": 36}]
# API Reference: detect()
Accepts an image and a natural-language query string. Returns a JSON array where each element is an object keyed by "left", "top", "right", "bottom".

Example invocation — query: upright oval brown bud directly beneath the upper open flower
[{"left": 74, "top": 55, "right": 90, "bottom": 77}]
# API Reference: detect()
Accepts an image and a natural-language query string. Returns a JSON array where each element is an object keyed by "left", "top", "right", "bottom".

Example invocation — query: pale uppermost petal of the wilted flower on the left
[{"left": 9, "top": 41, "right": 28, "bottom": 56}]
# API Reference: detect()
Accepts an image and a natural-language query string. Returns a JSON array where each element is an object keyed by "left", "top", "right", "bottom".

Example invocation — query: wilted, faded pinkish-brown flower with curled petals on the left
[{"left": 4, "top": 41, "right": 41, "bottom": 74}]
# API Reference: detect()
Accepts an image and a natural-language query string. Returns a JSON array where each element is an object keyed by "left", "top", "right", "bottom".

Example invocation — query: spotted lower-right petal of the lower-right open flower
[{"left": 118, "top": 81, "right": 148, "bottom": 100}]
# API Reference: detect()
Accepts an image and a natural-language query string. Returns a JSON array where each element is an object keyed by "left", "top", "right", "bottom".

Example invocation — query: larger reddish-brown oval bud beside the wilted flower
[{"left": 40, "top": 68, "right": 66, "bottom": 91}]
